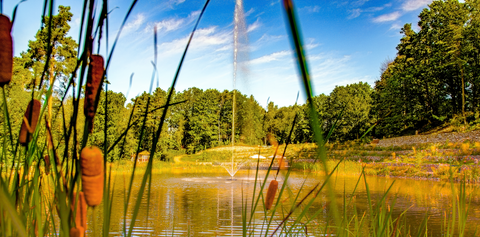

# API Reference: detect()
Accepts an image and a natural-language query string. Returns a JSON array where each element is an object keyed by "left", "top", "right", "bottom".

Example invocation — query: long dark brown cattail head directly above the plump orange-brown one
[{"left": 84, "top": 54, "right": 105, "bottom": 132}]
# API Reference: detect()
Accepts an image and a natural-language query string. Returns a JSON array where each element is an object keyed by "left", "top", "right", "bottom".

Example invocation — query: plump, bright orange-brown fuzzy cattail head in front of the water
[{"left": 80, "top": 146, "right": 103, "bottom": 206}]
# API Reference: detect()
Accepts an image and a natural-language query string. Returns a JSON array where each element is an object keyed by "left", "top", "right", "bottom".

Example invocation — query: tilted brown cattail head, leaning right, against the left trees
[{"left": 19, "top": 99, "right": 41, "bottom": 146}]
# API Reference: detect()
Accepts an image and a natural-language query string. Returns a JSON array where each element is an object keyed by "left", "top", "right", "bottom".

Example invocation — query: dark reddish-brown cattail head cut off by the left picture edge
[{"left": 0, "top": 14, "right": 13, "bottom": 87}]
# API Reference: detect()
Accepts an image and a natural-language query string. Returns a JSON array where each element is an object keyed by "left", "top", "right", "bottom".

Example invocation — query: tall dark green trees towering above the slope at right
[{"left": 374, "top": 0, "right": 480, "bottom": 137}]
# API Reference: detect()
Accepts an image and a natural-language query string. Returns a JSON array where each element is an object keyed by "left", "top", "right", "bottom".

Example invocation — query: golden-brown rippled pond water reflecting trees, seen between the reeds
[{"left": 88, "top": 170, "right": 480, "bottom": 236}]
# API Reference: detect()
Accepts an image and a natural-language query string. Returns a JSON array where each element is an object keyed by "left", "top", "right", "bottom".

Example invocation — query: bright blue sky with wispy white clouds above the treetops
[{"left": 3, "top": 0, "right": 431, "bottom": 106}]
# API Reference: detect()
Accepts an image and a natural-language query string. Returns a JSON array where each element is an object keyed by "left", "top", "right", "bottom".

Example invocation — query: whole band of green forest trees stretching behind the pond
[{"left": 0, "top": 0, "right": 480, "bottom": 159}]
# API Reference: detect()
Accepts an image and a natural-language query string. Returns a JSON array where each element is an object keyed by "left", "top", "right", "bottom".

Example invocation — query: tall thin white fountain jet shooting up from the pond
[{"left": 222, "top": 0, "right": 247, "bottom": 180}]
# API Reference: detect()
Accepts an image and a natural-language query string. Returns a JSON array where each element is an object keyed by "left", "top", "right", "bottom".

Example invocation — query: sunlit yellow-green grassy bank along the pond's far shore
[{"left": 182, "top": 141, "right": 480, "bottom": 183}]
